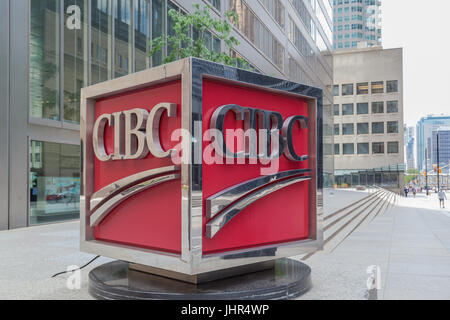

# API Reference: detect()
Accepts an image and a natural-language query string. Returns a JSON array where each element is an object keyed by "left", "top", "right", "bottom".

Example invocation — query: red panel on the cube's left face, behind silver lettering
[{"left": 95, "top": 81, "right": 181, "bottom": 253}]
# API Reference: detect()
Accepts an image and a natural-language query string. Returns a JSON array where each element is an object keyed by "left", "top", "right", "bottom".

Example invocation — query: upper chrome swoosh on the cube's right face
[{"left": 206, "top": 169, "right": 311, "bottom": 219}]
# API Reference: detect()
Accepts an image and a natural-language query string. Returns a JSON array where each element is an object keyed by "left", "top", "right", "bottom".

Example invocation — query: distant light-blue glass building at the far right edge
[{"left": 416, "top": 114, "right": 450, "bottom": 171}]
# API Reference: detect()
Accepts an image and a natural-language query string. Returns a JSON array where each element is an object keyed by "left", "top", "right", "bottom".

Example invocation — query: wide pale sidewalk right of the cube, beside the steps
[{"left": 301, "top": 194, "right": 450, "bottom": 300}]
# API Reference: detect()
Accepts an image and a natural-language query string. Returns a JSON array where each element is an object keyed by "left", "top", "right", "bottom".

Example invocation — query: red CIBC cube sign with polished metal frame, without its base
[{"left": 81, "top": 58, "right": 322, "bottom": 275}]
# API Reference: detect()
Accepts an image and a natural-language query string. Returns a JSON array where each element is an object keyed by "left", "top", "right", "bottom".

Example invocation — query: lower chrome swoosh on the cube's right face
[{"left": 206, "top": 176, "right": 311, "bottom": 239}]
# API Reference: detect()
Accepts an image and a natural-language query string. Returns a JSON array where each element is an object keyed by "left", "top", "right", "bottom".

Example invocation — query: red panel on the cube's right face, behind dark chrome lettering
[{"left": 202, "top": 79, "right": 310, "bottom": 254}]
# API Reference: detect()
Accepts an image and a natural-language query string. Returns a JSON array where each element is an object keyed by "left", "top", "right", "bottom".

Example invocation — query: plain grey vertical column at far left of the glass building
[{"left": 8, "top": 0, "right": 30, "bottom": 229}]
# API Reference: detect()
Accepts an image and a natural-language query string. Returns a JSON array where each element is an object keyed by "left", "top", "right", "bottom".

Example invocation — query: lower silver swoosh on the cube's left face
[{"left": 90, "top": 174, "right": 180, "bottom": 227}]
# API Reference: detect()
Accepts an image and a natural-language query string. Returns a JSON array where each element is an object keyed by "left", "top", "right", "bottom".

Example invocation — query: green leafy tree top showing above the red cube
[{"left": 150, "top": 4, "right": 251, "bottom": 70}]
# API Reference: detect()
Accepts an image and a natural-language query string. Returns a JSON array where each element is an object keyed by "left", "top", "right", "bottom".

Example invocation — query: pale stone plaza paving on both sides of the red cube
[{"left": 0, "top": 190, "right": 450, "bottom": 300}]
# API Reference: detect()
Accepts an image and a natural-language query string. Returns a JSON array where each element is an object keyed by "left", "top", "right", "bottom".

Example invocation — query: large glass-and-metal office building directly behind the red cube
[{"left": 0, "top": 0, "right": 333, "bottom": 230}]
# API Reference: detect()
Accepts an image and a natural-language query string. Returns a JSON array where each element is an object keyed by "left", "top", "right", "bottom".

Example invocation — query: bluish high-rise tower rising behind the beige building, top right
[{"left": 333, "top": 0, "right": 381, "bottom": 50}]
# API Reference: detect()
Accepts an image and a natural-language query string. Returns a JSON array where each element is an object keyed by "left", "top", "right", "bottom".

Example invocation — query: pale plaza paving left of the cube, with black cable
[{"left": 0, "top": 222, "right": 111, "bottom": 300}]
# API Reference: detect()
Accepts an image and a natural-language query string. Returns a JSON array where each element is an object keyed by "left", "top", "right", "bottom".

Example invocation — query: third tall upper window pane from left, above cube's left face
[{"left": 91, "top": 0, "right": 112, "bottom": 84}]
